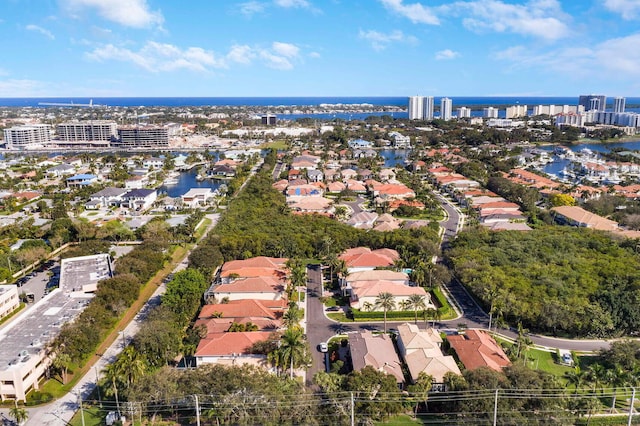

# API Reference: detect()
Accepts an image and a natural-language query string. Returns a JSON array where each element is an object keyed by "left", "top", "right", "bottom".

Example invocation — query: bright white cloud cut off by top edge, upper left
[{"left": 60, "top": 0, "right": 164, "bottom": 28}]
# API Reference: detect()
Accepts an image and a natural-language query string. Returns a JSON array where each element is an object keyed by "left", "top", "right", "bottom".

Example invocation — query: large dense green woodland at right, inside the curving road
[{"left": 447, "top": 227, "right": 640, "bottom": 337}]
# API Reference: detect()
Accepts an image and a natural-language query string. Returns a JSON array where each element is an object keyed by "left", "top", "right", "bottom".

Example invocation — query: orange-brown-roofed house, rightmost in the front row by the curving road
[{"left": 447, "top": 330, "right": 511, "bottom": 371}]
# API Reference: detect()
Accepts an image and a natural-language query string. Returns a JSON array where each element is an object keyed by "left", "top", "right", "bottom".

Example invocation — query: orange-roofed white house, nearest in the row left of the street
[{"left": 195, "top": 331, "right": 271, "bottom": 367}]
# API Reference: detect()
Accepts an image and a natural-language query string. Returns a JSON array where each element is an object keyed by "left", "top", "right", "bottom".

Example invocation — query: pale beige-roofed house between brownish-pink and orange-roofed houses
[{"left": 396, "top": 323, "right": 460, "bottom": 390}]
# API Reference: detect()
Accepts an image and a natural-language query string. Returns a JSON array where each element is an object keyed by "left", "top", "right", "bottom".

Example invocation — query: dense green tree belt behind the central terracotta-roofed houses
[{"left": 189, "top": 151, "right": 437, "bottom": 273}]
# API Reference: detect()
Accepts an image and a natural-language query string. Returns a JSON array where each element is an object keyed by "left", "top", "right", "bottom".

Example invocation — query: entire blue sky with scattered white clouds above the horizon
[{"left": 0, "top": 0, "right": 640, "bottom": 97}]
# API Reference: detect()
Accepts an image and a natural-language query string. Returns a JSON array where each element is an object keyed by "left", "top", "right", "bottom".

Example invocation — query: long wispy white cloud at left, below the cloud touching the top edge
[{"left": 86, "top": 42, "right": 226, "bottom": 72}]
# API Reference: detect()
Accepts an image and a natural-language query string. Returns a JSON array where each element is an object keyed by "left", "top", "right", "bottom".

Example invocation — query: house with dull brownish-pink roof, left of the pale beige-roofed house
[{"left": 349, "top": 330, "right": 404, "bottom": 387}]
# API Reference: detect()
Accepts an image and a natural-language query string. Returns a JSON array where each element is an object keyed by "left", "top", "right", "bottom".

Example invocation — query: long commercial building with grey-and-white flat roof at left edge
[{"left": 0, "top": 254, "right": 113, "bottom": 401}]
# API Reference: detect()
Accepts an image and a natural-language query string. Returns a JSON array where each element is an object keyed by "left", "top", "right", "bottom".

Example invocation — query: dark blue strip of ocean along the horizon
[{"left": 0, "top": 96, "right": 640, "bottom": 108}]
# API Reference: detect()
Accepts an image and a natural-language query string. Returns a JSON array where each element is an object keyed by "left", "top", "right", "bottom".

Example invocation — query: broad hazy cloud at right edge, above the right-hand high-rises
[{"left": 494, "top": 33, "right": 640, "bottom": 81}]
